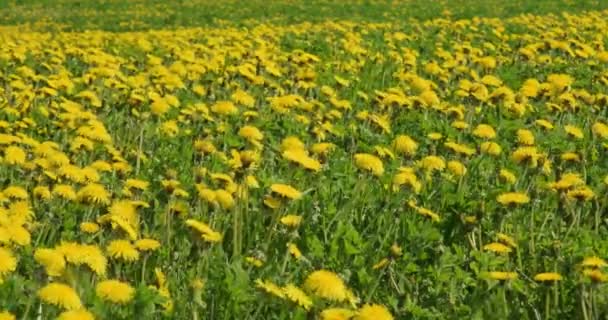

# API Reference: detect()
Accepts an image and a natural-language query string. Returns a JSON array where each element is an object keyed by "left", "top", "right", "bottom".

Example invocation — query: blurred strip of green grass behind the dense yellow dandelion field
[{"left": 0, "top": 0, "right": 608, "bottom": 31}]
